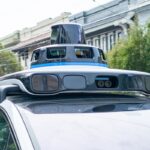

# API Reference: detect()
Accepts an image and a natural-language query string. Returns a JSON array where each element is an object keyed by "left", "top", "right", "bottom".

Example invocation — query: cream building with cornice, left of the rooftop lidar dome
[{"left": 0, "top": 12, "right": 71, "bottom": 69}]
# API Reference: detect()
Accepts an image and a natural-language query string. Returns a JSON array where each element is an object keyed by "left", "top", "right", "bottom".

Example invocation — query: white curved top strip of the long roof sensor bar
[{"left": 0, "top": 65, "right": 150, "bottom": 79}]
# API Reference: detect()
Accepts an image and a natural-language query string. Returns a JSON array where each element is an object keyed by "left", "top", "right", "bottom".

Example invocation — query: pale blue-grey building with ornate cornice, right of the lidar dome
[{"left": 69, "top": 0, "right": 150, "bottom": 52}]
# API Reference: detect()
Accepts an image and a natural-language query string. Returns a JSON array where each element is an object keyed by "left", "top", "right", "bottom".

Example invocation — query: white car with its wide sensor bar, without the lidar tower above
[{"left": 0, "top": 65, "right": 150, "bottom": 150}]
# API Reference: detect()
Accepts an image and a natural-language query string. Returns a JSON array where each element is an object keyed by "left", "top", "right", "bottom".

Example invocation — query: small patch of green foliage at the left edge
[{"left": 0, "top": 50, "right": 22, "bottom": 76}]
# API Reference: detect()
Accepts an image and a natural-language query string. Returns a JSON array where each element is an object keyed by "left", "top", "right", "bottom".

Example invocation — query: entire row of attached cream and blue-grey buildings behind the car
[{"left": 0, "top": 0, "right": 150, "bottom": 68}]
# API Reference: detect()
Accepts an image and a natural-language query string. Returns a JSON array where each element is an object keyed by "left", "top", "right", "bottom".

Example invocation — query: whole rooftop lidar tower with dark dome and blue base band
[{"left": 31, "top": 23, "right": 107, "bottom": 69}]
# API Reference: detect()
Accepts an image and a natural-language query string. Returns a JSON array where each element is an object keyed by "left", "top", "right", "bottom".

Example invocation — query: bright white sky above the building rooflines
[{"left": 0, "top": 0, "right": 111, "bottom": 37}]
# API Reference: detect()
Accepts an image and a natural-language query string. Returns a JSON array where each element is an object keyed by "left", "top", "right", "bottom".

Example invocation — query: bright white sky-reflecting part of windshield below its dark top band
[{"left": 22, "top": 110, "right": 150, "bottom": 150}]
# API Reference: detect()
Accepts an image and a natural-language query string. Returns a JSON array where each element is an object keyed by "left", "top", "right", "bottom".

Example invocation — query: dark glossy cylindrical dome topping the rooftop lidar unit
[{"left": 51, "top": 23, "right": 86, "bottom": 44}]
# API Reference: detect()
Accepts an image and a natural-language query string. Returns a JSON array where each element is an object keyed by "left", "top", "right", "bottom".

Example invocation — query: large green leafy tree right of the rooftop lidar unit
[{"left": 107, "top": 24, "right": 150, "bottom": 72}]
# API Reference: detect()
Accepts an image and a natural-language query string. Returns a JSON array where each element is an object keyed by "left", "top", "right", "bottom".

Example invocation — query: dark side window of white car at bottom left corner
[{"left": 0, "top": 111, "right": 18, "bottom": 150}]
